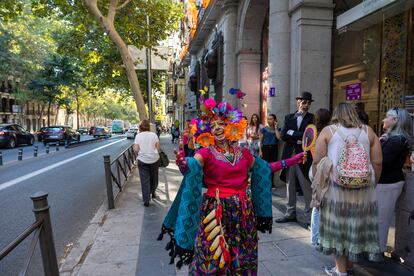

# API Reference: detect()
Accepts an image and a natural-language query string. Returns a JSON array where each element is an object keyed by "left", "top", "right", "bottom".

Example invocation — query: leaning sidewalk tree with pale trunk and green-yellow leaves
[{"left": 35, "top": 0, "right": 182, "bottom": 119}]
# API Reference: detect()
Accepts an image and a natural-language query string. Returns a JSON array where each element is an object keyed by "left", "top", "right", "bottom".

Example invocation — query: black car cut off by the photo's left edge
[{"left": 0, "top": 124, "right": 35, "bottom": 149}]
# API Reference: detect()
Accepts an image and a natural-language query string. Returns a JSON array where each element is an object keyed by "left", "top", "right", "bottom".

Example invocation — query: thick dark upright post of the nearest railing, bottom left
[{"left": 30, "top": 192, "right": 59, "bottom": 276}]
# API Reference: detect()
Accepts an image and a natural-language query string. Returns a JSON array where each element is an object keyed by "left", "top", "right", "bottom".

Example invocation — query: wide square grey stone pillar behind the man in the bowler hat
[{"left": 289, "top": 0, "right": 334, "bottom": 111}]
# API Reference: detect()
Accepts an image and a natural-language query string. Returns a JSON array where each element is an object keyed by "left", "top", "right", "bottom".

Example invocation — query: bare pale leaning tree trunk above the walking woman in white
[{"left": 84, "top": 0, "right": 148, "bottom": 120}]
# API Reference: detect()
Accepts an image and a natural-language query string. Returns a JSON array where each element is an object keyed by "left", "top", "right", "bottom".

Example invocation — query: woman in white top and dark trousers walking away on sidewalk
[{"left": 133, "top": 120, "right": 160, "bottom": 207}]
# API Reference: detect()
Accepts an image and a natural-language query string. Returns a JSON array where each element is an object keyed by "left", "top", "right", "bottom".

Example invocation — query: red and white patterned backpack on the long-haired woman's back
[{"left": 336, "top": 128, "right": 371, "bottom": 189}]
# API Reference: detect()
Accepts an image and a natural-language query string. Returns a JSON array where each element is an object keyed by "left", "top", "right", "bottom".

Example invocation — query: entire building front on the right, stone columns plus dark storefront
[{"left": 179, "top": 0, "right": 414, "bottom": 133}]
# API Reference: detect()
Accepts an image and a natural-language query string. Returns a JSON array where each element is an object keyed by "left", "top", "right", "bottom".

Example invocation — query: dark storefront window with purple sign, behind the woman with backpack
[{"left": 331, "top": 1, "right": 414, "bottom": 133}]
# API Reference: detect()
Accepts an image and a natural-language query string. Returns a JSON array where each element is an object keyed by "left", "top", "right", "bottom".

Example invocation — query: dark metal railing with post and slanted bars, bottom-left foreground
[{"left": 0, "top": 192, "right": 59, "bottom": 276}]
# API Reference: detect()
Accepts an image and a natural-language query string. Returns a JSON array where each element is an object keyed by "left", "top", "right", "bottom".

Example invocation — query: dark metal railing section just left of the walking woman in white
[{"left": 104, "top": 145, "right": 136, "bottom": 209}]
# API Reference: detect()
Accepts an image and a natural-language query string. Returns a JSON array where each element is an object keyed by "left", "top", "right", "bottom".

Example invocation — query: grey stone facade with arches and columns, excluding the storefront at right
[{"left": 175, "top": 0, "right": 334, "bottom": 124}]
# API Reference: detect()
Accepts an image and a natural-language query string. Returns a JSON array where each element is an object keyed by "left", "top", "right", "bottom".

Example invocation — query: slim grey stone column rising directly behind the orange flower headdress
[{"left": 223, "top": 0, "right": 238, "bottom": 106}]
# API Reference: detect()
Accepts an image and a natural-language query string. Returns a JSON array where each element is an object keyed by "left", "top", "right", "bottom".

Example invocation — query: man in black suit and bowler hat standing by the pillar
[{"left": 276, "top": 92, "right": 313, "bottom": 223}]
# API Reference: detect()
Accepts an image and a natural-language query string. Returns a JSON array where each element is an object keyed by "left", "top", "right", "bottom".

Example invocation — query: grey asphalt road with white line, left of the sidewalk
[{"left": 0, "top": 137, "right": 132, "bottom": 275}]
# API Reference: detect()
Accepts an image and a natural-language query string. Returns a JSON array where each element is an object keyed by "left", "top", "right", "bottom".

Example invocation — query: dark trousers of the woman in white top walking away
[{"left": 138, "top": 160, "right": 158, "bottom": 202}]
